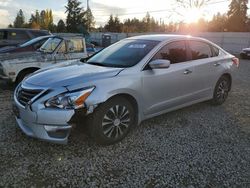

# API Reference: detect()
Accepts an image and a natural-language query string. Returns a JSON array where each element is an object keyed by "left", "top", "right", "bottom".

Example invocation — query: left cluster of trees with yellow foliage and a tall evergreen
[{"left": 9, "top": 0, "right": 95, "bottom": 34}]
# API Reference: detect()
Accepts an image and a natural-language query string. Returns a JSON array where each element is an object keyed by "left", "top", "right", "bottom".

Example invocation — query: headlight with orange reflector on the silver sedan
[{"left": 45, "top": 87, "right": 95, "bottom": 109}]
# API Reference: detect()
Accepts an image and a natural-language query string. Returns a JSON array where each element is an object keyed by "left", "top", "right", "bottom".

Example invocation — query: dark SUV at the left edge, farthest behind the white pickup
[{"left": 0, "top": 28, "right": 50, "bottom": 48}]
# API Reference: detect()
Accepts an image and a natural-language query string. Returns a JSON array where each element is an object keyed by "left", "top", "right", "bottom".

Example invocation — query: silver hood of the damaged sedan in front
[{"left": 24, "top": 64, "right": 123, "bottom": 88}]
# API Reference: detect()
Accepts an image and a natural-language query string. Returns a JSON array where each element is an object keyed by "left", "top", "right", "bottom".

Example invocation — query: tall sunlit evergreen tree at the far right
[{"left": 227, "top": 0, "right": 248, "bottom": 32}]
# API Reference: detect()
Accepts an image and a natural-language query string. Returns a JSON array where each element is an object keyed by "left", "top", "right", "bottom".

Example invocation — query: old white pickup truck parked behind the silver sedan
[{"left": 0, "top": 34, "right": 88, "bottom": 83}]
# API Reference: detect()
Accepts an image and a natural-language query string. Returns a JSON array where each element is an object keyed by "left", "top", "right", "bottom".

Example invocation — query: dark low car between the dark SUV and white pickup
[{"left": 0, "top": 35, "right": 51, "bottom": 53}]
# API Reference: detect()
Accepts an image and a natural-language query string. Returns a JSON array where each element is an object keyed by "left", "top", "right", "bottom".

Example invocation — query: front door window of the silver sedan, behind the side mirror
[{"left": 152, "top": 41, "right": 187, "bottom": 64}]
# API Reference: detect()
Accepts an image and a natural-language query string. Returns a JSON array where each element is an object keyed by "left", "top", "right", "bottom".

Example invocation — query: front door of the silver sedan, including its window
[{"left": 143, "top": 41, "right": 200, "bottom": 115}]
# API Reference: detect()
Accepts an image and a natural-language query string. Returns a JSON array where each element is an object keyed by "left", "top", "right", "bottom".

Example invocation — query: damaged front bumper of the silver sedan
[{"left": 13, "top": 94, "right": 88, "bottom": 144}]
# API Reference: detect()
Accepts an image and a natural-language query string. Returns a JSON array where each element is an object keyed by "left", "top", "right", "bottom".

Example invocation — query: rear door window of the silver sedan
[{"left": 189, "top": 41, "right": 212, "bottom": 60}]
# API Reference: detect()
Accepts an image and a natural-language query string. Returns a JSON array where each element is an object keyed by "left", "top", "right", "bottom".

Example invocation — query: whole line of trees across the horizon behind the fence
[{"left": 9, "top": 0, "right": 250, "bottom": 33}]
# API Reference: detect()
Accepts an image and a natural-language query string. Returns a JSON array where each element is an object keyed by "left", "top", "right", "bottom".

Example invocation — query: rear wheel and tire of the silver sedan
[{"left": 212, "top": 76, "right": 231, "bottom": 105}]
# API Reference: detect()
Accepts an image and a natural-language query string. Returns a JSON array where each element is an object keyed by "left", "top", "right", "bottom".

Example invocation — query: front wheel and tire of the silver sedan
[{"left": 88, "top": 97, "right": 136, "bottom": 145}]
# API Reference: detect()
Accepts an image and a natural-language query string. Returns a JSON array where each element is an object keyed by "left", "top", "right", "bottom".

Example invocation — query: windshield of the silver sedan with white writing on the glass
[{"left": 87, "top": 39, "right": 159, "bottom": 67}]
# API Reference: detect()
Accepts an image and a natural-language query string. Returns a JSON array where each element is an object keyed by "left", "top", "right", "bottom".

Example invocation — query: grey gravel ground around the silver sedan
[{"left": 0, "top": 60, "right": 250, "bottom": 188}]
